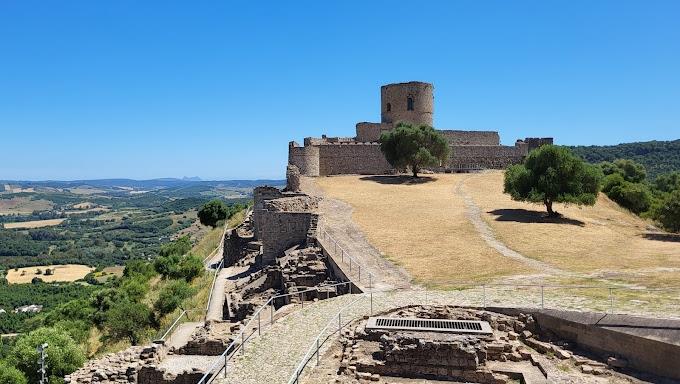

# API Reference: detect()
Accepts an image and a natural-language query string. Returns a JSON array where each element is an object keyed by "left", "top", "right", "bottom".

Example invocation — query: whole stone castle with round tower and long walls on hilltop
[{"left": 288, "top": 81, "right": 553, "bottom": 176}]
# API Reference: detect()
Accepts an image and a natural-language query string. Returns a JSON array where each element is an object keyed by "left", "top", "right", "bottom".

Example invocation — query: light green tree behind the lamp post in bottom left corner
[{"left": 9, "top": 328, "right": 85, "bottom": 383}]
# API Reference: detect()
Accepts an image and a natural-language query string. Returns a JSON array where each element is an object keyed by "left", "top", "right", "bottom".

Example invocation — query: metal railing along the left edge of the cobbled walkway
[{"left": 198, "top": 281, "right": 353, "bottom": 384}]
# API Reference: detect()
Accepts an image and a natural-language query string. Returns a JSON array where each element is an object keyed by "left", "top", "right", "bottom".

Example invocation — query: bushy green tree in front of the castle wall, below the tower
[{"left": 380, "top": 123, "right": 451, "bottom": 177}]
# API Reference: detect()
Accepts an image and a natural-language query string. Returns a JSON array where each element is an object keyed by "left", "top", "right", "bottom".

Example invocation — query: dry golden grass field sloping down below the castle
[{"left": 315, "top": 171, "right": 680, "bottom": 286}]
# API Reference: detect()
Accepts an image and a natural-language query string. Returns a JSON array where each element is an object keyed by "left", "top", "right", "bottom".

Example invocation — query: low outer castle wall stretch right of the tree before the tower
[{"left": 448, "top": 145, "right": 526, "bottom": 171}]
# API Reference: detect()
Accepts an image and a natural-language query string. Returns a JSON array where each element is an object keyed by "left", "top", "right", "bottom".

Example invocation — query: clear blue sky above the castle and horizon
[{"left": 0, "top": 0, "right": 680, "bottom": 180}]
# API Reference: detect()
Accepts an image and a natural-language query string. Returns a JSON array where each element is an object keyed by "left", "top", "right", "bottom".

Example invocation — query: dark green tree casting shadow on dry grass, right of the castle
[{"left": 504, "top": 145, "right": 602, "bottom": 216}]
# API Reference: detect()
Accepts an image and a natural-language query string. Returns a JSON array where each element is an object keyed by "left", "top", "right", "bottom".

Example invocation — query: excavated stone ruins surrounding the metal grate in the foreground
[{"left": 312, "top": 306, "right": 657, "bottom": 384}]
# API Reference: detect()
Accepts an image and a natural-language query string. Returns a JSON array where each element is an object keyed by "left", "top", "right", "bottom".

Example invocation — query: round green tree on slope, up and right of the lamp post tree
[{"left": 104, "top": 300, "right": 152, "bottom": 345}]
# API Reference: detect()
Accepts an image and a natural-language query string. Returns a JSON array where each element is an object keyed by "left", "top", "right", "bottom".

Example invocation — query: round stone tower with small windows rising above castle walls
[{"left": 380, "top": 81, "right": 434, "bottom": 127}]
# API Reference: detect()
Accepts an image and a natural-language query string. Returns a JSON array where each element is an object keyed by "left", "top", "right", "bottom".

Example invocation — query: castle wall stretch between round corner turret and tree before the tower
[{"left": 319, "top": 143, "right": 392, "bottom": 175}]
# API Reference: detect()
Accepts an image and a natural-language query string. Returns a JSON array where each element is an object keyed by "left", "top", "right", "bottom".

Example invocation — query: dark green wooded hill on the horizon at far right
[{"left": 570, "top": 140, "right": 680, "bottom": 179}]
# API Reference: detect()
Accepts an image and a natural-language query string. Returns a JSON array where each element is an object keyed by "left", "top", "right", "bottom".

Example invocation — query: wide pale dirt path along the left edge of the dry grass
[{"left": 300, "top": 177, "right": 411, "bottom": 289}]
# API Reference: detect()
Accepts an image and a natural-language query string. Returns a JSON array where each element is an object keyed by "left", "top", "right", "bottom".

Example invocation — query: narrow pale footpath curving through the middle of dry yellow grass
[{"left": 455, "top": 177, "right": 572, "bottom": 276}]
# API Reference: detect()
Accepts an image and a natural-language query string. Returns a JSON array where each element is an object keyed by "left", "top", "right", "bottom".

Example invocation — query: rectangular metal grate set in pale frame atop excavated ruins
[{"left": 366, "top": 317, "right": 493, "bottom": 334}]
